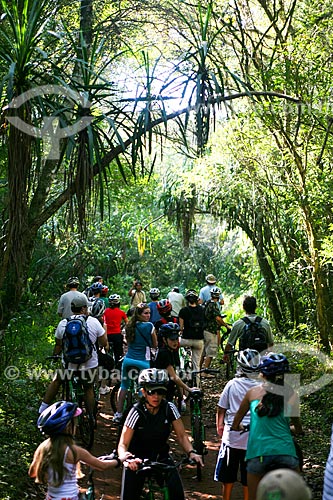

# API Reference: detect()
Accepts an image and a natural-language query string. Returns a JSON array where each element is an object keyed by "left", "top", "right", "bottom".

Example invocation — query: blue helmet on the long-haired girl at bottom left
[{"left": 37, "top": 401, "right": 82, "bottom": 436}]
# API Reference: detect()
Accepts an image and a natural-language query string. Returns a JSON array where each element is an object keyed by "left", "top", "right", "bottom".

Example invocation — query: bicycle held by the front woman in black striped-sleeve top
[{"left": 137, "top": 457, "right": 196, "bottom": 500}]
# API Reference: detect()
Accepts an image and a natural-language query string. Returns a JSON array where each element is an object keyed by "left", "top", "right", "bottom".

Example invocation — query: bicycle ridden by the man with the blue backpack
[{"left": 46, "top": 355, "right": 99, "bottom": 450}]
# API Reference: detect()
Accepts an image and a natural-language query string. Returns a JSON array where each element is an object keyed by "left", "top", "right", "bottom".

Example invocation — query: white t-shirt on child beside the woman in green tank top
[{"left": 218, "top": 377, "right": 259, "bottom": 450}]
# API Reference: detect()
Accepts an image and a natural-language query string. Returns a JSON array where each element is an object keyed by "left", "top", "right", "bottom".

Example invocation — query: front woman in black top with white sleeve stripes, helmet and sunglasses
[{"left": 118, "top": 368, "right": 203, "bottom": 500}]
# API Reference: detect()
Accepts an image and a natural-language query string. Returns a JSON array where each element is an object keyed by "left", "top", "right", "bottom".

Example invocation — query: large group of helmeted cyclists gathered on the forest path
[{"left": 29, "top": 275, "right": 310, "bottom": 500}]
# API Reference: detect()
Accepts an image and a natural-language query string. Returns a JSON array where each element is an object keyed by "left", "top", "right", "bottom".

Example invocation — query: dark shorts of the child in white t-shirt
[{"left": 215, "top": 445, "right": 247, "bottom": 486}]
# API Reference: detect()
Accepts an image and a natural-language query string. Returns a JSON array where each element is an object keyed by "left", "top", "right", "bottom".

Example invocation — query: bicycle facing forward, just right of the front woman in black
[{"left": 188, "top": 368, "right": 221, "bottom": 481}]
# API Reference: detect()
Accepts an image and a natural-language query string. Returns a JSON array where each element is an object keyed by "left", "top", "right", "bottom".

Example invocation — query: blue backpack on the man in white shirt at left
[{"left": 62, "top": 316, "right": 94, "bottom": 365}]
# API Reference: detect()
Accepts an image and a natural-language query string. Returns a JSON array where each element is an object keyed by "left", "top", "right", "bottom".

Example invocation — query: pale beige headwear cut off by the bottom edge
[{"left": 256, "top": 469, "right": 312, "bottom": 500}]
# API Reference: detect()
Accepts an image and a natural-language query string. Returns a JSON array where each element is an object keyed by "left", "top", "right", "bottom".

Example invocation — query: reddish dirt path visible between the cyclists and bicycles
[{"left": 82, "top": 380, "right": 243, "bottom": 500}]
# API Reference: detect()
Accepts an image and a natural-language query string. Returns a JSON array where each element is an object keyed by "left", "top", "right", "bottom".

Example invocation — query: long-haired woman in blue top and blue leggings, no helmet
[{"left": 113, "top": 303, "right": 157, "bottom": 424}]
